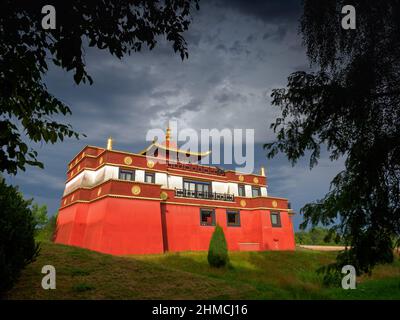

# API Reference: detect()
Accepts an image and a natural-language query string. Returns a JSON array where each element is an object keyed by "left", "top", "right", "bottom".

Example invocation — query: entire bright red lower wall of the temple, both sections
[{"left": 55, "top": 197, "right": 295, "bottom": 255}]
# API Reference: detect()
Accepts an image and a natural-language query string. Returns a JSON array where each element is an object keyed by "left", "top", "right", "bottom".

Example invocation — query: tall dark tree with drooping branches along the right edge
[{"left": 265, "top": 0, "right": 400, "bottom": 274}]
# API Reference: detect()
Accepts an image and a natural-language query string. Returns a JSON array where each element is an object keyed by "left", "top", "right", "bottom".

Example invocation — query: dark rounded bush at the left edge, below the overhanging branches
[{"left": 0, "top": 178, "right": 39, "bottom": 295}]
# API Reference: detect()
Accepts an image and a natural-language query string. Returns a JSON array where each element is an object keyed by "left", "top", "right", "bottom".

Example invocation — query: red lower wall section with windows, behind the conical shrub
[{"left": 161, "top": 204, "right": 295, "bottom": 251}]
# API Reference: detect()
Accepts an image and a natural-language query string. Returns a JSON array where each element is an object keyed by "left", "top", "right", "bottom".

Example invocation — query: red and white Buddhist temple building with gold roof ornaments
[{"left": 55, "top": 129, "right": 295, "bottom": 255}]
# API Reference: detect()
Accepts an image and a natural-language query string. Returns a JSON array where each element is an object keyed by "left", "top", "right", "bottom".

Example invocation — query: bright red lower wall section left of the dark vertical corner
[{"left": 55, "top": 197, "right": 164, "bottom": 255}]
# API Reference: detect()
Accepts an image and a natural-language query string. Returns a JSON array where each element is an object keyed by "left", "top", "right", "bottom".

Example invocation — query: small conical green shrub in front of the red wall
[{"left": 207, "top": 225, "right": 229, "bottom": 268}]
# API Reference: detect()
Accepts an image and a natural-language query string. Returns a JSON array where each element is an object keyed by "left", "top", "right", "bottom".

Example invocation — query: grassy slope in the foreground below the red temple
[{"left": 8, "top": 242, "right": 400, "bottom": 299}]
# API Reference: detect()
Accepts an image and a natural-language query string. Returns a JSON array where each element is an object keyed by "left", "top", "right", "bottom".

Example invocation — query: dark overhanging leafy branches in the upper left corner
[{"left": 0, "top": 0, "right": 198, "bottom": 174}]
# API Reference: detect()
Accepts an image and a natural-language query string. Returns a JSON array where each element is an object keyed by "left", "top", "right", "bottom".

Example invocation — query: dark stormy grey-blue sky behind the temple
[{"left": 8, "top": 0, "right": 343, "bottom": 230}]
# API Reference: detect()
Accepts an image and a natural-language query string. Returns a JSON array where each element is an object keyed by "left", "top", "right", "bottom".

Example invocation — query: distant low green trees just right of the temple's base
[{"left": 295, "top": 227, "right": 343, "bottom": 246}]
